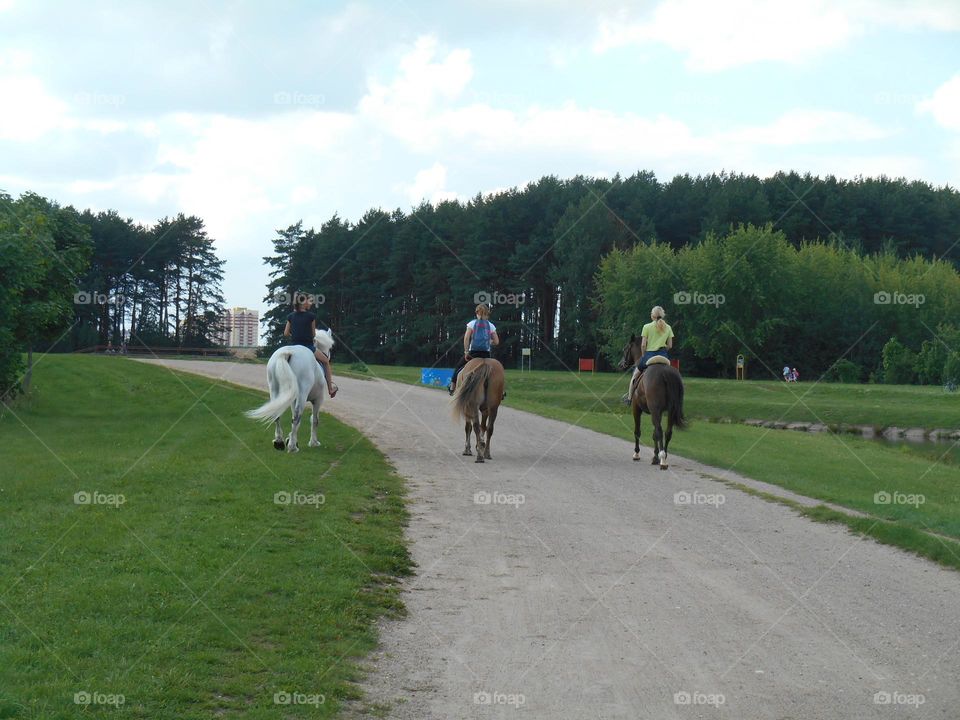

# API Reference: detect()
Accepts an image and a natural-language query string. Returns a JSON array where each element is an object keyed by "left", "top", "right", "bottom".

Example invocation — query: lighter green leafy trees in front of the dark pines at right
[{"left": 597, "top": 225, "right": 960, "bottom": 384}]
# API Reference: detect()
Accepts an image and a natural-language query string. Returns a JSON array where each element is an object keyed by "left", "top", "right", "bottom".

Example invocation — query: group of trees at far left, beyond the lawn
[{"left": 0, "top": 192, "right": 223, "bottom": 399}]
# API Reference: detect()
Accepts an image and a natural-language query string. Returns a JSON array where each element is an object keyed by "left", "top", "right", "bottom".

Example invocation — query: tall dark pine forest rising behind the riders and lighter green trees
[{"left": 264, "top": 172, "right": 960, "bottom": 378}]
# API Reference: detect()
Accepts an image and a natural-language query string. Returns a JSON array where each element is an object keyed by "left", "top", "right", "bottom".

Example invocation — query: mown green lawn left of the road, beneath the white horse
[{"left": 0, "top": 356, "right": 411, "bottom": 720}]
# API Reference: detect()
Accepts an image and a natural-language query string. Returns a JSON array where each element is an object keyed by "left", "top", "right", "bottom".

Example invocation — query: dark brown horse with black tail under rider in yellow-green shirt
[{"left": 618, "top": 335, "right": 687, "bottom": 470}]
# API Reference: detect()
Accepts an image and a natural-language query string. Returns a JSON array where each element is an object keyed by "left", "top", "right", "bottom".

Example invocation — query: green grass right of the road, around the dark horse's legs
[{"left": 344, "top": 366, "right": 960, "bottom": 568}]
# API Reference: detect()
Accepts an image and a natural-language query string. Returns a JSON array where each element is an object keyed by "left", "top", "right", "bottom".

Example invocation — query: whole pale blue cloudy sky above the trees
[{"left": 0, "top": 0, "right": 960, "bottom": 324}]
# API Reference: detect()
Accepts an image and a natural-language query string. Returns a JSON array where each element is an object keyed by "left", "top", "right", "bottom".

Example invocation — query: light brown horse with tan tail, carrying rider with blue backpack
[{"left": 453, "top": 358, "right": 504, "bottom": 462}]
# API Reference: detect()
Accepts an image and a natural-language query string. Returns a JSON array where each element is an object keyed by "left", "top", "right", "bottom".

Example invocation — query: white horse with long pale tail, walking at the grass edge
[{"left": 247, "top": 330, "right": 333, "bottom": 452}]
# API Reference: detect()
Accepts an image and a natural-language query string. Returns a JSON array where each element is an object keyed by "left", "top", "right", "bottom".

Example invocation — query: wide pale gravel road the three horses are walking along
[{"left": 139, "top": 361, "right": 960, "bottom": 720}]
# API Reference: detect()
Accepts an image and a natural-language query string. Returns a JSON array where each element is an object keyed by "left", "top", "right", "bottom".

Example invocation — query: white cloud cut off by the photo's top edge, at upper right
[{"left": 594, "top": 0, "right": 960, "bottom": 72}]
